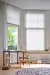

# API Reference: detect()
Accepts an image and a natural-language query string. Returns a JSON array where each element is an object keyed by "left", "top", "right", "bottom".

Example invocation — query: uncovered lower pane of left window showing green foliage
[{"left": 8, "top": 25, "right": 18, "bottom": 50}]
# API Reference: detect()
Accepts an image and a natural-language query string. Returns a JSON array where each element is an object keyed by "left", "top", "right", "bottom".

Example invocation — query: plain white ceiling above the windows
[{"left": 2, "top": 0, "right": 50, "bottom": 10}]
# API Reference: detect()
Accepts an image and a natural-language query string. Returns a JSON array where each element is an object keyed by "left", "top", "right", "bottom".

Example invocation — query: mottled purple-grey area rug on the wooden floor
[{"left": 16, "top": 67, "right": 50, "bottom": 75}]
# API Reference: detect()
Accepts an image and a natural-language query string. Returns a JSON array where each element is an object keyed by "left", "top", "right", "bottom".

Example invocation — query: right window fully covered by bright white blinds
[{"left": 26, "top": 13, "right": 45, "bottom": 50}]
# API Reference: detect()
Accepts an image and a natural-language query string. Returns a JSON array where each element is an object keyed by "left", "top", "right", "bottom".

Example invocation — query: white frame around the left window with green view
[{"left": 4, "top": 4, "right": 20, "bottom": 50}]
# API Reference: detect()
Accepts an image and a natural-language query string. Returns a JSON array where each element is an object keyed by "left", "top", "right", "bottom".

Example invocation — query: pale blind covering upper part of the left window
[{"left": 6, "top": 5, "right": 20, "bottom": 25}]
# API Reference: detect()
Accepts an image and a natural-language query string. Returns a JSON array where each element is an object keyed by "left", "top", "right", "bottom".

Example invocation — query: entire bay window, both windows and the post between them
[{"left": 6, "top": 5, "right": 45, "bottom": 50}]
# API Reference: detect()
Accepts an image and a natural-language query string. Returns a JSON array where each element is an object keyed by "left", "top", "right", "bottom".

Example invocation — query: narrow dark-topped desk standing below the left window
[{"left": 3, "top": 51, "right": 27, "bottom": 66}]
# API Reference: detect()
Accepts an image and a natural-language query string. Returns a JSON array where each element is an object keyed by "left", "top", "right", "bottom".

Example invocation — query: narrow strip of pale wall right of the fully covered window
[{"left": 46, "top": 11, "right": 50, "bottom": 49}]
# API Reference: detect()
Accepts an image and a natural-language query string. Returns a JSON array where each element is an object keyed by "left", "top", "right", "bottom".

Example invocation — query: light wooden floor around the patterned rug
[{"left": 0, "top": 64, "right": 50, "bottom": 75}]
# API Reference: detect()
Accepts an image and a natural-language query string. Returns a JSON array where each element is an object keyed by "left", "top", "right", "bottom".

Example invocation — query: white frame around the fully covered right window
[{"left": 25, "top": 10, "right": 46, "bottom": 51}]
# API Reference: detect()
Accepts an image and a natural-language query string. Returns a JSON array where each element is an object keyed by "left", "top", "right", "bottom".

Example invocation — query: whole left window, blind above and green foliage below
[{"left": 6, "top": 4, "right": 20, "bottom": 50}]
